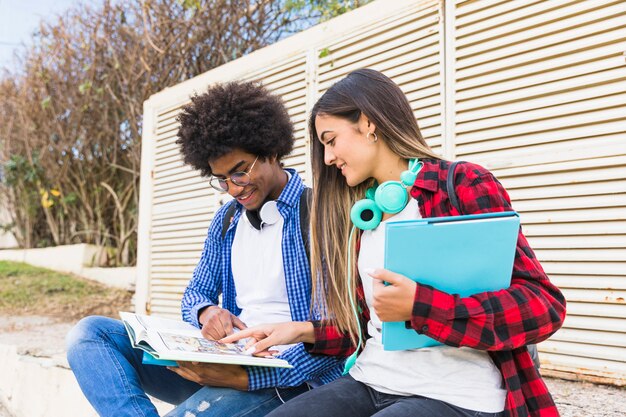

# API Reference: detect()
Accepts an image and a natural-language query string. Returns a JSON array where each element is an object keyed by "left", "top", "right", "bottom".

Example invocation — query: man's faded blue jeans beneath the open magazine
[{"left": 66, "top": 316, "right": 308, "bottom": 417}]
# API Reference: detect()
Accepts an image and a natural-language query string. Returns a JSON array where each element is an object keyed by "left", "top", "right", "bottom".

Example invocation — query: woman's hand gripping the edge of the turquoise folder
[{"left": 368, "top": 269, "right": 417, "bottom": 321}]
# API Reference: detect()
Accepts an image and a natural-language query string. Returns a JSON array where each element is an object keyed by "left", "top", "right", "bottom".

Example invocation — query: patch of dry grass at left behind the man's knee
[{"left": 0, "top": 261, "right": 131, "bottom": 320}]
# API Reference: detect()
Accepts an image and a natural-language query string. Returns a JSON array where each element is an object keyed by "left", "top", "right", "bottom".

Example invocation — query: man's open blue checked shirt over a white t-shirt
[{"left": 182, "top": 169, "right": 343, "bottom": 391}]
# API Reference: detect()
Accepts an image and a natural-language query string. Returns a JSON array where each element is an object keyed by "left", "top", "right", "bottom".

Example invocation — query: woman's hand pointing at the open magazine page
[{"left": 220, "top": 321, "right": 315, "bottom": 356}]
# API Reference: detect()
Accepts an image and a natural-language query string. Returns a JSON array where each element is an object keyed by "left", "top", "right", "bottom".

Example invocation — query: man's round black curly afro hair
[{"left": 176, "top": 82, "right": 294, "bottom": 177}]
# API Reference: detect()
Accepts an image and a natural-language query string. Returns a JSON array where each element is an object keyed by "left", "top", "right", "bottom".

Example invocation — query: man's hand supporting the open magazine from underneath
[{"left": 167, "top": 362, "right": 248, "bottom": 391}]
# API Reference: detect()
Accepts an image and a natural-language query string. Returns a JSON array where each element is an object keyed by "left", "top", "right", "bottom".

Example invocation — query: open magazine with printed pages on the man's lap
[{"left": 120, "top": 312, "right": 292, "bottom": 368}]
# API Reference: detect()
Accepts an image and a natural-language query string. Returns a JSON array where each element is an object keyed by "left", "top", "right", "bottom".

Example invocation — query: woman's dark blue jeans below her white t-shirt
[{"left": 267, "top": 375, "right": 504, "bottom": 417}]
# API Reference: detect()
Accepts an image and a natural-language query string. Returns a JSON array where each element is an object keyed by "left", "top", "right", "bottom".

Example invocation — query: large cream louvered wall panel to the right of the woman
[{"left": 454, "top": 0, "right": 626, "bottom": 383}]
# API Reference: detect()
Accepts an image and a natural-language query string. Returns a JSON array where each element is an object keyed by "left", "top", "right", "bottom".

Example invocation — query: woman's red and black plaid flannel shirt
[{"left": 309, "top": 160, "right": 565, "bottom": 417}]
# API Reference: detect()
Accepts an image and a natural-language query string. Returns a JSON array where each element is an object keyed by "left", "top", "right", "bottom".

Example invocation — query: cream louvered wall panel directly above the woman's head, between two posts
[{"left": 317, "top": 1, "right": 443, "bottom": 152}]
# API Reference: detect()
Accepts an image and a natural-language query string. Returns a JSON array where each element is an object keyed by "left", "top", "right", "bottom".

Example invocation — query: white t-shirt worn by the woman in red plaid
[{"left": 350, "top": 198, "right": 506, "bottom": 413}]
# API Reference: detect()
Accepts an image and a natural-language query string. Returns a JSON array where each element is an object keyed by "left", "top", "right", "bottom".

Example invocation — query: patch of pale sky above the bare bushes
[{"left": 0, "top": 0, "right": 80, "bottom": 70}]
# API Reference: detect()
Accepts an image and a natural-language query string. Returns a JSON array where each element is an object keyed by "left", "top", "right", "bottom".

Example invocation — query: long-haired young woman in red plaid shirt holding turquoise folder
[{"left": 223, "top": 69, "right": 565, "bottom": 417}]
